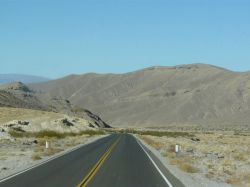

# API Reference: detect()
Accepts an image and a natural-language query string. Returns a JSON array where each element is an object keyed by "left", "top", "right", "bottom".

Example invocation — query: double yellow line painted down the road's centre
[{"left": 77, "top": 138, "right": 120, "bottom": 187}]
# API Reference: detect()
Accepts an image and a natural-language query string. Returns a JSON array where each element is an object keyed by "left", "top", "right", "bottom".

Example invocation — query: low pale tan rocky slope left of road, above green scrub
[{"left": 0, "top": 107, "right": 104, "bottom": 139}]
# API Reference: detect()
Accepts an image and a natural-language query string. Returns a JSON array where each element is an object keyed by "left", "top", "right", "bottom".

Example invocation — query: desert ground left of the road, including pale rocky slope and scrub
[{"left": 0, "top": 108, "right": 106, "bottom": 179}]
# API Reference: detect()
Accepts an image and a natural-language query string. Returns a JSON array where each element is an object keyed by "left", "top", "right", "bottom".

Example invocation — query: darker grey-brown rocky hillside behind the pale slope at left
[{"left": 0, "top": 82, "right": 109, "bottom": 127}]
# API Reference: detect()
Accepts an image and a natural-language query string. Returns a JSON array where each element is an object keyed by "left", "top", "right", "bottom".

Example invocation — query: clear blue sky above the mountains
[{"left": 0, "top": 0, "right": 250, "bottom": 78}]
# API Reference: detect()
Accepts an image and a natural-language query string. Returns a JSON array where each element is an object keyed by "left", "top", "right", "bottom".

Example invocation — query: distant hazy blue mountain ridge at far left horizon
[{"left": 0, "top": 74, "right": 50, "bottom": 84}]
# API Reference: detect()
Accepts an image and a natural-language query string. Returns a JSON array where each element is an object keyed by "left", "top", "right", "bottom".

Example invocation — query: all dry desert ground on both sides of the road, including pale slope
[{"left": 0, "top": 107, "right": 250, "bottom": 187}]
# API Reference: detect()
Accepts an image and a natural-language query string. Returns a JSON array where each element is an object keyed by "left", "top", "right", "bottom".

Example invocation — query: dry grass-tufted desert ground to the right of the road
[{"left": 137, "top": 132, "right": 250, "bottom": 186}]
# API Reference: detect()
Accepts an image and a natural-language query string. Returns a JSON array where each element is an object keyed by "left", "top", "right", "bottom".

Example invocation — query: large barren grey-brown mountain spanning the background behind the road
[{"left": 31, "top": 64, "right": 250, "bottom": 127}]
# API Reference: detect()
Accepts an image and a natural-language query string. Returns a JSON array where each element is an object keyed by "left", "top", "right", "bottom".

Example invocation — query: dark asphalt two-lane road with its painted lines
[{"left": 0, "top": 134, "right": 184, "bottom": 187}]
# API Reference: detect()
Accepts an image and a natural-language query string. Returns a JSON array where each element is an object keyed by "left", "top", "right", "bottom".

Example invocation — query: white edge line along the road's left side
[{"left": 0, "top": 136, "right": 110, "bottom": 183}]
